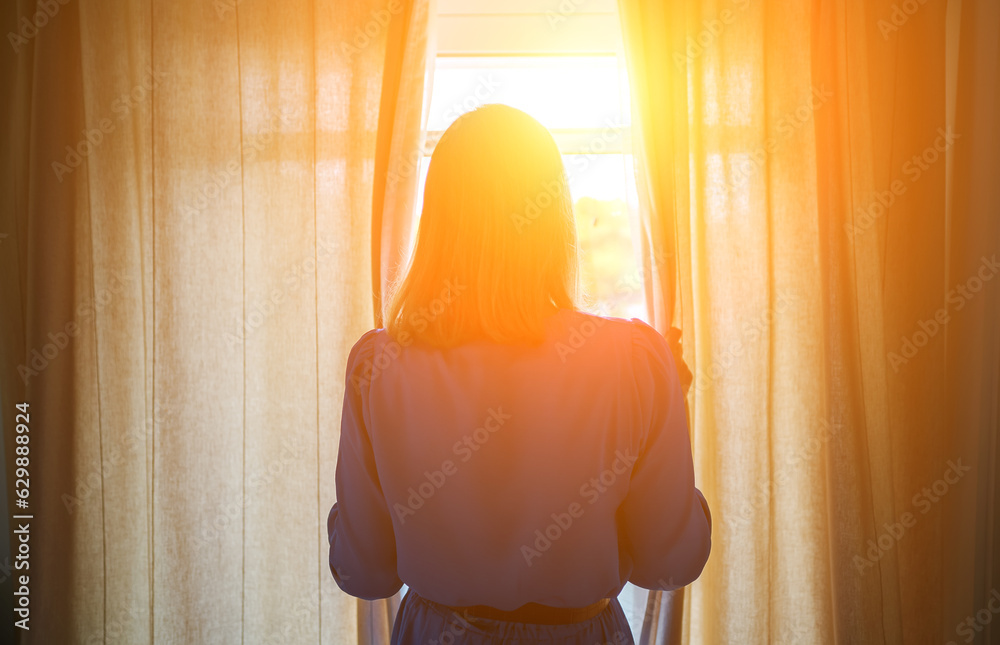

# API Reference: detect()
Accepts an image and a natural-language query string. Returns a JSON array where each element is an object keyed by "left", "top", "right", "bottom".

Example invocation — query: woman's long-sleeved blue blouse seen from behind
[{"left": 327, "top": 309, "right": 711, "bottom": 610}]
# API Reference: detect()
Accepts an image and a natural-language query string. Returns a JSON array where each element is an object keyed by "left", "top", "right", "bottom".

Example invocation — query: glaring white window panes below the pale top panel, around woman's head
[{"left": 414, "top": 55, "right": 646, "bottom": 319}]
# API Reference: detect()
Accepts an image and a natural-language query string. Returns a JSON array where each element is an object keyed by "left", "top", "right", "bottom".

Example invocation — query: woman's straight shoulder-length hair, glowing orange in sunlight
[{"left": 383, "top": 105, "right": 580, "bottom": 347}]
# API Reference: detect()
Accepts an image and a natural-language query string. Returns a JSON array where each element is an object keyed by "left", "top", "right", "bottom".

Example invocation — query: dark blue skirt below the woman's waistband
[{"left": 390, "top": 589, "right": 635, "bottom": 645}]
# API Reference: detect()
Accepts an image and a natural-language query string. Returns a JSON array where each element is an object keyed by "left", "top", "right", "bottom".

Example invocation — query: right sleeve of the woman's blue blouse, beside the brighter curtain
[{"left": 620, "top": 318, "right": 712, "bottom": 590}]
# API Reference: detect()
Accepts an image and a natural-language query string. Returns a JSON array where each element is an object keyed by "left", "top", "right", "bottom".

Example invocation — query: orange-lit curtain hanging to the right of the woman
[{"left": 619, "top": 0, "right": 1000, "bottom": 643}]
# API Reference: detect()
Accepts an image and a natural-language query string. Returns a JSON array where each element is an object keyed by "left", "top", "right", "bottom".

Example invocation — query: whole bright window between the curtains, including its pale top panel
[{"left": 404, "top": 0, "right": 648, "bottom": 634}]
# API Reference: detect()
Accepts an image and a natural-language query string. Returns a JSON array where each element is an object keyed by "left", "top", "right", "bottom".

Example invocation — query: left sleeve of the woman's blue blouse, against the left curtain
[{"left": 327, "top": 330, "right": 403, "bottom": 600}]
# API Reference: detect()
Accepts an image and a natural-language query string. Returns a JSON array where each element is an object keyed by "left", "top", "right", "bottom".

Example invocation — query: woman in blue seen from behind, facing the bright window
[{"left": 327, "top": 105, "right": 711, "bottom": 645}]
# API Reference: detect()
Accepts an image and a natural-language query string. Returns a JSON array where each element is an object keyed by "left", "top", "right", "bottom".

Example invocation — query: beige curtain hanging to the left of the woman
[{"left": 0, "top": 0, "right": 427, "bottom": 643}]
